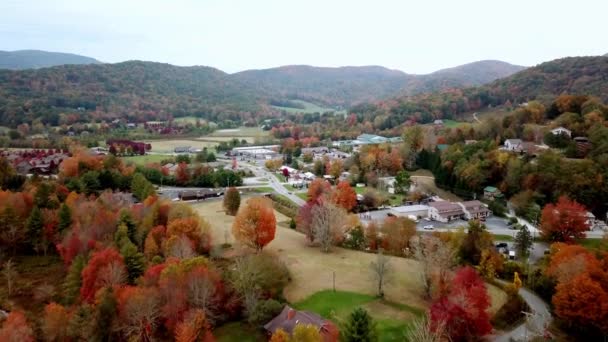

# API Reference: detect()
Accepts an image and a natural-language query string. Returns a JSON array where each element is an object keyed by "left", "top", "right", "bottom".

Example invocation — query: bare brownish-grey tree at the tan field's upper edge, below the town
[{"left": 311, "top": 201, "right": 347, "bottom": 253}]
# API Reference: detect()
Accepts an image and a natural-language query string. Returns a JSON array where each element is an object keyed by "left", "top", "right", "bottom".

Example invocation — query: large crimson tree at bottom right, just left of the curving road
[{"left": 431, "top": 267, "right": 492, "bottom": 341}]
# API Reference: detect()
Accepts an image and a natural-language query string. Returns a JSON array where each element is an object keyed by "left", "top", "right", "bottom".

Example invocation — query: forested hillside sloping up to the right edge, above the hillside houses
[{"left": 351, "top": 56, "right": 608, "bottom": 130}]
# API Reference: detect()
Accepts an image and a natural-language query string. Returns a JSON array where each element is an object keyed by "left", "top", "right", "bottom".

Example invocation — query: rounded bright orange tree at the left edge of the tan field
[{"left": 232, "top": 197, "right": 277, "bottom": 252}]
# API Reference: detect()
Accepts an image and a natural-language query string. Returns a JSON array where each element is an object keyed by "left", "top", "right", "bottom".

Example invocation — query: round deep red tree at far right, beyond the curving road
[{"left": 540, "top": 196, "right": 589, "bottom": 242}]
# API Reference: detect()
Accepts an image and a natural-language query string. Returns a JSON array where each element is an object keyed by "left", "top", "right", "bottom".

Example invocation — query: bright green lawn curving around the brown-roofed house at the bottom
[{"left": 294, "top": 290, "right": 423, "bottom": 341}]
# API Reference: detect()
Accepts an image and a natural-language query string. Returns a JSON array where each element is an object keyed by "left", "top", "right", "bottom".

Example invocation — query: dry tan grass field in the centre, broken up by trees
[{"left": 192, "top": 196, "right": 506, "bottom": 312}]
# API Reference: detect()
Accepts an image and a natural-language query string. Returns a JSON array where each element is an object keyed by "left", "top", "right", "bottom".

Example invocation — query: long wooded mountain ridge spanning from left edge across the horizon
[{"left": 0, "top": 61, "right": 520, "bottom": 127}]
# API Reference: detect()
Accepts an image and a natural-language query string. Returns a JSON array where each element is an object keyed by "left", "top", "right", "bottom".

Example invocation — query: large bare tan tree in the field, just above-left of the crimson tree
[{"left": 411, "top": 235, "right": 455, "bottom": 298}]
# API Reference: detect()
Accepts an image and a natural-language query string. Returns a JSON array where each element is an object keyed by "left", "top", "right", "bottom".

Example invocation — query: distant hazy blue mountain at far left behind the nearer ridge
[{"left": 0, "top": 50, "right": 100, "bottom": 70}]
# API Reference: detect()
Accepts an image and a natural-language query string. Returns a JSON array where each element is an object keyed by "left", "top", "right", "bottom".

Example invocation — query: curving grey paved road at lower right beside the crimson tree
[{"left": 494, "top": 280, "right": 551, "bottom": 342}]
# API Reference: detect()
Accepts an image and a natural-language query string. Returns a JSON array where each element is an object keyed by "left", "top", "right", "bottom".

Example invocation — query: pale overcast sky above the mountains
[{"left": 0, "top": 0, "right": 608, "bottom": 74}]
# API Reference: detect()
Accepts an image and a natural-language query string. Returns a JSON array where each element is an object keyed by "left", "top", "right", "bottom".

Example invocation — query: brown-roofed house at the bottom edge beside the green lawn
[{"left": 264, "top": 305, "right": 339, "bottom": 342}]
